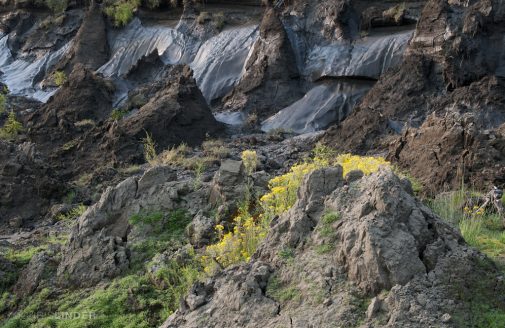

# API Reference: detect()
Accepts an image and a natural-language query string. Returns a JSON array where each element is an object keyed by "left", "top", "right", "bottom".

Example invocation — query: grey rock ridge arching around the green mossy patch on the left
[{"left": 58, "top": 166, "right": 208, "bottom": 286}]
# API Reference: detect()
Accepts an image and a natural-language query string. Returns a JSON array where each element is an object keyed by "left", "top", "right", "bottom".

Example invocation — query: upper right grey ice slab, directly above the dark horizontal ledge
[{"left": 304, "top": 31, "right": 413, "bottom": 79}]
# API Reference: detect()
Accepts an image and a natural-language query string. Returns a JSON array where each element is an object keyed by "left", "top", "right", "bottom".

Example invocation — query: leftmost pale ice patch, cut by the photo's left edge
[{"left": 0, "top": 35, "right": 71, "bottom": 102}]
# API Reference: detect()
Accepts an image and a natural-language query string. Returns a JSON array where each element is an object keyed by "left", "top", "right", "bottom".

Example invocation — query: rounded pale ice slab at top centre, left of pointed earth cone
[{"left": 190, "top": 26, "right": 259, "bottom": 103}]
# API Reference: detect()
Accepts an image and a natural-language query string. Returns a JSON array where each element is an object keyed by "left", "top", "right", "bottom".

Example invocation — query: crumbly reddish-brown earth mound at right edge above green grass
[{"left": 389, "top": 77, "right": 505, "bottom": 194}]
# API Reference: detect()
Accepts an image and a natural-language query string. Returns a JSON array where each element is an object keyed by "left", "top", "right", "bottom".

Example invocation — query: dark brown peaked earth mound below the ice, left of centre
[{"left": 104, "top": 66, "right": 223, "bottom": 162}]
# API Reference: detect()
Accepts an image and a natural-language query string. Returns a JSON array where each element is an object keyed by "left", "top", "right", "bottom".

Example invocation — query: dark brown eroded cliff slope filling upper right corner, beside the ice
[{"left": 326, "top": 1, "right": 504, "bottom": 192}]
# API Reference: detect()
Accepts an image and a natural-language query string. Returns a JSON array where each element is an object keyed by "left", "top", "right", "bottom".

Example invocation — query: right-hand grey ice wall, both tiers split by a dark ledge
[{"left": 261, "top": 31, "right": 412, "bottom": 133}]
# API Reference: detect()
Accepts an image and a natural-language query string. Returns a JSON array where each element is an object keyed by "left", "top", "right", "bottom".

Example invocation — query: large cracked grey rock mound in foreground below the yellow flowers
[{"left": 163, "top": 167, "right": 505, "bottom": 328}]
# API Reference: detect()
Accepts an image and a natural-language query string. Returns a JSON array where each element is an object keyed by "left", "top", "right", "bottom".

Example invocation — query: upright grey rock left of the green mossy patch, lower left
[{"left": 58, "top": 174, "right": 137, "bottom": 286}]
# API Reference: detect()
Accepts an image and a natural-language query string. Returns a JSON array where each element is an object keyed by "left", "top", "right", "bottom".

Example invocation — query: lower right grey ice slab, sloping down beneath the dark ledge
[{"left": 261, "top": 81, "right": 373, "bottom": 134}]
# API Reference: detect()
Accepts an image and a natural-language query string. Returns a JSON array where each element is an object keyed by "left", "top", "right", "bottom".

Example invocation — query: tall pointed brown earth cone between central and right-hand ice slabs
[{"left": 223, "top": 9, "right": 302, "bottom": 118}]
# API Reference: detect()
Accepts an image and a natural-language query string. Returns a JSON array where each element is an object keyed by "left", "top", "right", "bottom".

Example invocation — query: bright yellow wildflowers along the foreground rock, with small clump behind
[{"left": 202, "top": 151, "right": 390, "bottom": 274}]
